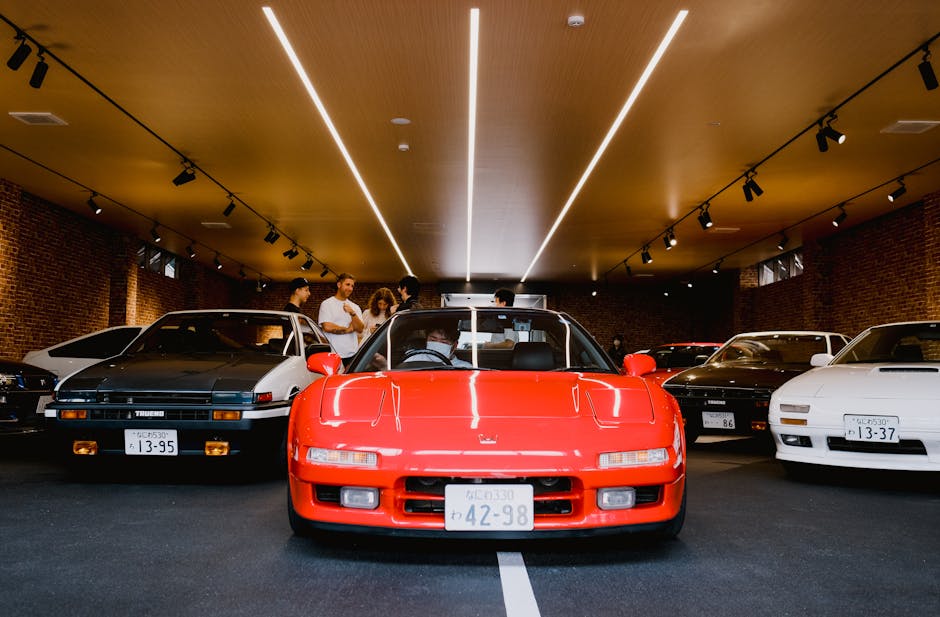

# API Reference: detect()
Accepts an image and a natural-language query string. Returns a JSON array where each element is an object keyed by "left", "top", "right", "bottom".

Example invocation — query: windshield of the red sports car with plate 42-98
[{"left": 347, "top": 308, "right": 618, "bottom": 373}]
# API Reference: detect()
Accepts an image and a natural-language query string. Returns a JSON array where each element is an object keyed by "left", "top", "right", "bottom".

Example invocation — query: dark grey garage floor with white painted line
[{"left": 0, "top": 437, "right": 940, "bottom": 617}]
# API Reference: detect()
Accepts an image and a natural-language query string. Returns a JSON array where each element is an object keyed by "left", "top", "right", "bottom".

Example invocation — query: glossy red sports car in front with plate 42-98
[{"left": 287, "top": 308, "right": 686, "bottom": 538}]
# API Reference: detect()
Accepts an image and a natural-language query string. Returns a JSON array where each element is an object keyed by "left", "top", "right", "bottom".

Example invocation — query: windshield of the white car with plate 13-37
[{"left": 833, "top": 322, "right": 940, "bottom": 364}]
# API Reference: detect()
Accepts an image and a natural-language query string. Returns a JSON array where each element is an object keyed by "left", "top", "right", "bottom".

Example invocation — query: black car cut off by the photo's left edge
[{"left": 0, "top": 360, "right": 56, "bottom": 433}]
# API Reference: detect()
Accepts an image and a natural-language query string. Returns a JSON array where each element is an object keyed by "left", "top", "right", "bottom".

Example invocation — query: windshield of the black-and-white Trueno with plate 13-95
[{"left": 128, "top": 312, "right": 295, "bottom": 355}]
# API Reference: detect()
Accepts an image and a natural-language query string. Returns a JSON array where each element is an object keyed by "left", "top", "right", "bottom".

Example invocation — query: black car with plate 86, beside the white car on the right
[{"left": 663, "top": 331, "right": 849, "bottom": 443}]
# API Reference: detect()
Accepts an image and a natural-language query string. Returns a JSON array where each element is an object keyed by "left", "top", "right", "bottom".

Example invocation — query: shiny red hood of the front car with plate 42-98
[{"left": 320, "top": 371, "right": 654, "bottom": 424}]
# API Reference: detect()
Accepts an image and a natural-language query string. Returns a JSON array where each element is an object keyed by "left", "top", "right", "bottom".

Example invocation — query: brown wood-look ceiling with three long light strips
[{"left": 0, "top": 0, "right": 940, "bottom": 284}]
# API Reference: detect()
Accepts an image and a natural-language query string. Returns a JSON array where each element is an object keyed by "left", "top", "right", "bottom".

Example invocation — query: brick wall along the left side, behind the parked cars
[{"left": 0, "top": 179, "right": 235, "bottom": 359}]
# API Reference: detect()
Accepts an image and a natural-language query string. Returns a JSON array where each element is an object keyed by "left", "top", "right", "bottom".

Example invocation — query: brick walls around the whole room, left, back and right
[{"left": 0, "top": 179, "right": 940, "bottom": 358}]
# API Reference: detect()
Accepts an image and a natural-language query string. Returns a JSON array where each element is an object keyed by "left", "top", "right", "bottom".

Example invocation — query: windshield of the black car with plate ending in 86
[{"left": 710, "top": 334, "right": 829, "bottom": 366}]
